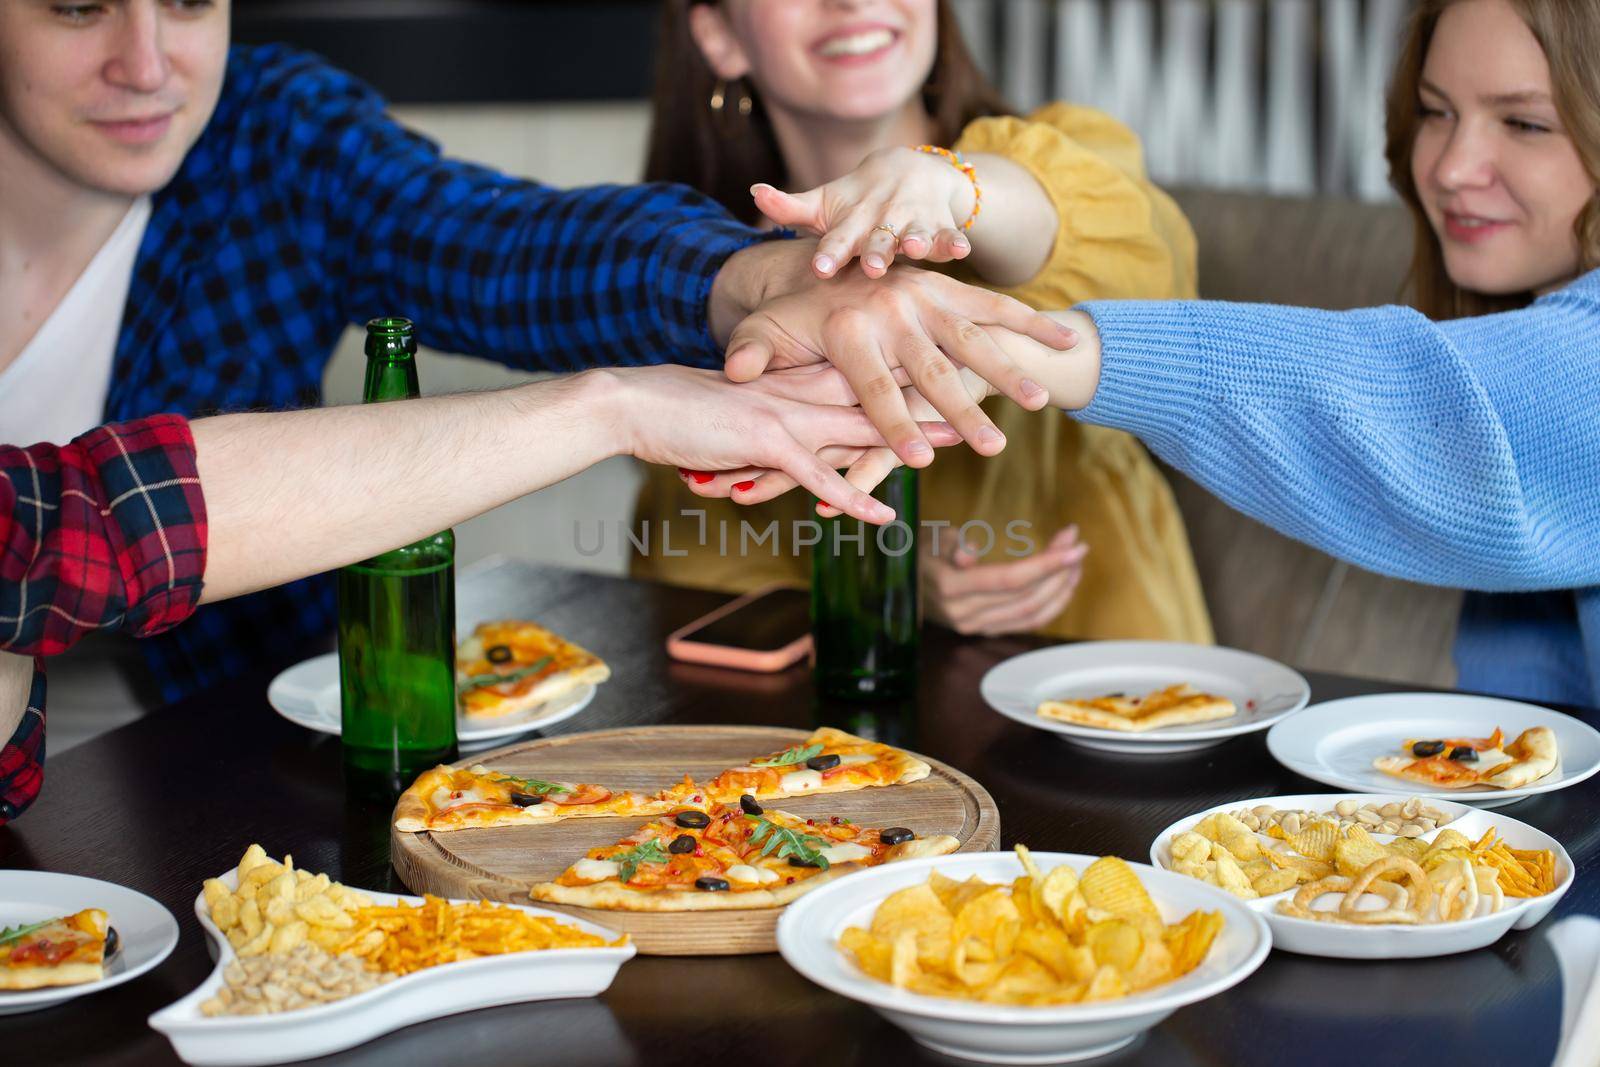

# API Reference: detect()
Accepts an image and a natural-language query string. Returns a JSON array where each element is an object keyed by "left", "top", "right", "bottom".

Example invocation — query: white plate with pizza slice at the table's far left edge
[{"left": 0, "top": 870, "right": 178, "bottom": 1016}]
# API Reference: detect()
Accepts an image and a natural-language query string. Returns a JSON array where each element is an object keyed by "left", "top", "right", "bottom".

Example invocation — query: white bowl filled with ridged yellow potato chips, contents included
[{"left": 778, "top": 846, "right": 1272, "bottom": 1064}]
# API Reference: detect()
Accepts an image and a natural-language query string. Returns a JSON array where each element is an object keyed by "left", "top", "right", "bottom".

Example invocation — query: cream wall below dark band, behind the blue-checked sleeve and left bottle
[{"left": 323, "top": 102, "right": 650, "bottom": 574}]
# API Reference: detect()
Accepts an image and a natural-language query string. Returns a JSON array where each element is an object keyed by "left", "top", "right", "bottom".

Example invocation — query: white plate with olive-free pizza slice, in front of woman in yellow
[{"left": 979, "top": 641, "right": 1310, "bottom": 755}]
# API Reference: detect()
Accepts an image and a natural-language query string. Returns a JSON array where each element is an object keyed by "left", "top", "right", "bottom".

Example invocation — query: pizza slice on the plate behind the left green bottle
[{"left": 456, "top": 621, "right": 611, "bottom": 718}]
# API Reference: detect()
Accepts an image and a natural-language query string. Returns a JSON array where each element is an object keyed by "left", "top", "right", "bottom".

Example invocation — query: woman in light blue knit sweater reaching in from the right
[{"left": 696, "top": 0, "right": 1600, "bottom": 705}]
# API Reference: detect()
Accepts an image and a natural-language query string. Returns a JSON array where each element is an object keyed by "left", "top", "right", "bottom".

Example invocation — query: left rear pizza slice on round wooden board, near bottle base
[{"left": 395, "top": 763, "right": 693, "bottom": 833}]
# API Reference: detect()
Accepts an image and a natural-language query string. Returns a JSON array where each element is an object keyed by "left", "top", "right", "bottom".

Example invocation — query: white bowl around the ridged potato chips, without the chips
[{"left": 778, "top": 853, "right": 1272, "bottom": 1064}]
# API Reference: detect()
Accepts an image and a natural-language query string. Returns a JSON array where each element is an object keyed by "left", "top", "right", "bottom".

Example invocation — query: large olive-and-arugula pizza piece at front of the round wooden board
[{"left": 528, "top": 793, "right": 960, "bottom": 912}]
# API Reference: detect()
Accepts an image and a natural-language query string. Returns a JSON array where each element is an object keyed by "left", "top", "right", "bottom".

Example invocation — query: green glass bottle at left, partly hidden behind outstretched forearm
[{"left": 339, "top": 318, "right": 456, "bottom": 789}]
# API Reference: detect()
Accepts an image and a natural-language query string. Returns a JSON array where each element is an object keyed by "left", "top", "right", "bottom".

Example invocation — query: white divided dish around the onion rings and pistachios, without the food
[{"left": 1150, "top": 792, "right": 1574, "bottom": 960}]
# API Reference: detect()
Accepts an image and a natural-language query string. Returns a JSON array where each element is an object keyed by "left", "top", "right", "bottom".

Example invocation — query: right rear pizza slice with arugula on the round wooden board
[{"left": 656, "top": 726, "right": 933, "bottom": 805}]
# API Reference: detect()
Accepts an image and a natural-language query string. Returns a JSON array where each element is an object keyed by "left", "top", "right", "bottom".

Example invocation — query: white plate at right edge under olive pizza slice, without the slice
[{"left": 1267, "top": 693, "right": 1600, "bottom": 808}]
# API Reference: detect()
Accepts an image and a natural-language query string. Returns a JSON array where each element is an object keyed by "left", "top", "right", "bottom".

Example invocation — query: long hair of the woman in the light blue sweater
[{"left": 1384, "top": 0, "right": 1600, "bottom": 318}]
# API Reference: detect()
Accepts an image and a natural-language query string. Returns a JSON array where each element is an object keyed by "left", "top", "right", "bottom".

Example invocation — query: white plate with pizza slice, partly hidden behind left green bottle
[{"left": 267, "top": 619, "right": 611, "bottom": 747}]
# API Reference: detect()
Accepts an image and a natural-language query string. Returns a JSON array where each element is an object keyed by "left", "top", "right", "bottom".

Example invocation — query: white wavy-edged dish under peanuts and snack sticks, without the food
[{"left": 150, "top": 870, "right": 638, "bottom": 1067}]
